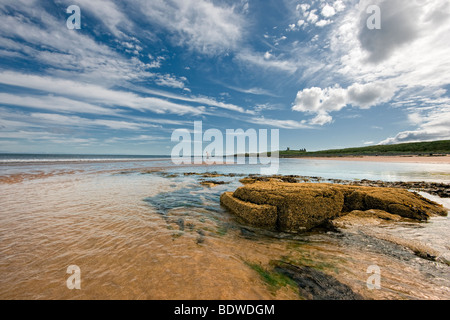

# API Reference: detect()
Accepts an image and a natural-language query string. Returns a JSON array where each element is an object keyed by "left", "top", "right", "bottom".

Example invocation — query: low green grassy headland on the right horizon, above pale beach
[{"left": 280, "top": 140, "right": 450, "bottom": 158}]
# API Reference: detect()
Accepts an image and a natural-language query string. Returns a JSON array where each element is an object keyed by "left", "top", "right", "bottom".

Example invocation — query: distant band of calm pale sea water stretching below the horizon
[{"left": 0, "top": 154, "right": 450, "bottom": 183}]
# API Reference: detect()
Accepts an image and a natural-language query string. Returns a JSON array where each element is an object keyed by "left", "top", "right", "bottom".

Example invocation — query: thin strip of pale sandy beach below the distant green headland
[{"left": 299, "top": 156, "right": 450, "bottom": 164}]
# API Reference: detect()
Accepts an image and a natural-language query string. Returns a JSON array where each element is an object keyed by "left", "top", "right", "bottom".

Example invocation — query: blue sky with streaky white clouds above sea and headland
[{"left": 0, "top": 0, "right": 450, "bottom": 155}]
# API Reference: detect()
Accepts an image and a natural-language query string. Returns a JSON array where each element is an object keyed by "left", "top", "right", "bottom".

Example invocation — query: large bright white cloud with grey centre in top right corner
[{"left": 329, "top": 0, "right": 450, "bottom": 89}]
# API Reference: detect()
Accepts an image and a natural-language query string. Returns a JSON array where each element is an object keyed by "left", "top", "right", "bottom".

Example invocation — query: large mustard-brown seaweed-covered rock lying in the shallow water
[{"left": 221, "top": 180, "right": 447, "bottom": 232}]
